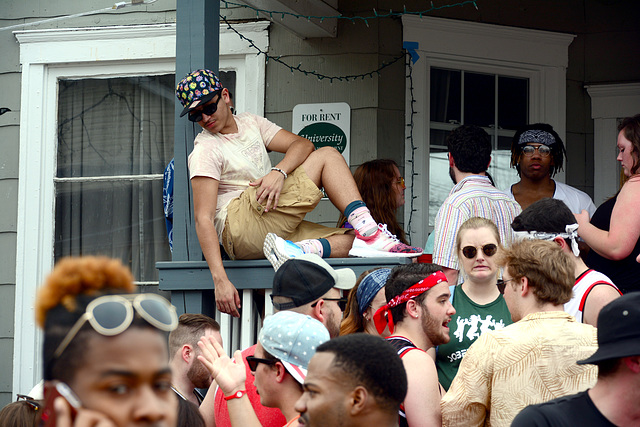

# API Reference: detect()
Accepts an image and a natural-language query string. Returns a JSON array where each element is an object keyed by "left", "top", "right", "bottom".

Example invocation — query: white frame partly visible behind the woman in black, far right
[{"left": 586, "top": 83, "right": 640, "bottom": 206}]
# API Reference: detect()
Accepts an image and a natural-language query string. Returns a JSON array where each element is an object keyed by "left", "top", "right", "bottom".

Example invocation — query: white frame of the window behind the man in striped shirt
[{"left": 402, "top": 15, "right": 575, "bottom": 245}]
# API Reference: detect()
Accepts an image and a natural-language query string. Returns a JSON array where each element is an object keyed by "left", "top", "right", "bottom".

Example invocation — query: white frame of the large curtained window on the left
[{"left": 13, "top": 22, "right": 269, "bottom": 393}]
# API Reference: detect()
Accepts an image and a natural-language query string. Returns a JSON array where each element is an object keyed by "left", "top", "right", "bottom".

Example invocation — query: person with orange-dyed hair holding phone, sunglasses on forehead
[{"left": 36, "top": 257, "right": 178, "bottom": 427}]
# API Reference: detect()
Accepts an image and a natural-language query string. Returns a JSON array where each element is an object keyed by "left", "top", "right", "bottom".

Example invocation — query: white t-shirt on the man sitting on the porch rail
[{"left": 189, "top": 113, "right": 282, "bottom": 239}]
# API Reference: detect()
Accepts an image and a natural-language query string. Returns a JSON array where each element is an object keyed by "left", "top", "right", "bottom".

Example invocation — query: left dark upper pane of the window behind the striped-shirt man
[{"left": 430, "top": 68, "right": 461, "bottom": 123}]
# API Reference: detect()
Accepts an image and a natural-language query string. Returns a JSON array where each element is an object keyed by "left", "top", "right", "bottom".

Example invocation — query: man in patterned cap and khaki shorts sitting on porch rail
[{"left": 176, "top": 70, "right": 422, "bottom": 317}]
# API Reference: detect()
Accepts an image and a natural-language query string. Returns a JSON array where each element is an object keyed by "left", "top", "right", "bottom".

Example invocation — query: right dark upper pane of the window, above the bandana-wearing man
[{"left": 498, "top": 76, "right": 529, "bottom": 129}]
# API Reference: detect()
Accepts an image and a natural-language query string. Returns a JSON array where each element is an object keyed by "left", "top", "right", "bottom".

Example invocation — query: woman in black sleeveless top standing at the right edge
[{"left": 576, "top": 114, "right": 640, "bottom": 293}]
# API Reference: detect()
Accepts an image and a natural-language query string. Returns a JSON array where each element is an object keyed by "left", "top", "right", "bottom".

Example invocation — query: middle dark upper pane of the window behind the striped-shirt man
[{"left": 464, "top": 73, "right": 495, "bottom": 127}]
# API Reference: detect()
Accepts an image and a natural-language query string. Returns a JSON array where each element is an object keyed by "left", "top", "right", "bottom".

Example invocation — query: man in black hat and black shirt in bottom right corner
[{"left": 512, "top": 292, "right": 640, "bottom": 427}]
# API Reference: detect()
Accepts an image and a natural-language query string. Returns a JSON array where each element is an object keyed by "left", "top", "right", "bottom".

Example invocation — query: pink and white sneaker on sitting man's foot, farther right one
[{"left": 349, "top": 224, "right": 422, "bottom": 258}]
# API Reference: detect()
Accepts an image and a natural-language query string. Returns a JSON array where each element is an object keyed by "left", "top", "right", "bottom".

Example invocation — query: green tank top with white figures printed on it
[{"left": 436, "top": 285, "right": 512, "bottom": 390}]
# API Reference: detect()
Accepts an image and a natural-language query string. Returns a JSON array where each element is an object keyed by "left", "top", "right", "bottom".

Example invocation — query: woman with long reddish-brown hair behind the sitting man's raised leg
[{"left": 338, "top": 159, "right": 408, "bottom": 244}]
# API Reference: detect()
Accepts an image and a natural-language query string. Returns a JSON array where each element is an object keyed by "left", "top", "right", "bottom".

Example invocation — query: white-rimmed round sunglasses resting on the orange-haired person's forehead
[{"left": 53, "top": 294, "right": 178, "bottom": 359}]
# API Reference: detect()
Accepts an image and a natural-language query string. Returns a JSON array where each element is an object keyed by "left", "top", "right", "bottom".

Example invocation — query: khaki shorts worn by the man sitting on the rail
[{"left": 222, "top": 166, "right": 350, "bottom": 259}]
